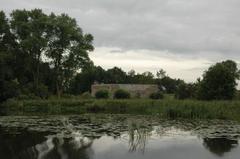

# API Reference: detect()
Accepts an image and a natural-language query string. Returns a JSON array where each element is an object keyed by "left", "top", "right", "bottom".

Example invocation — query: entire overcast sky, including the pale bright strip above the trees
[{"left": 0, "top": 0, "right": 240, "bottom": 81}]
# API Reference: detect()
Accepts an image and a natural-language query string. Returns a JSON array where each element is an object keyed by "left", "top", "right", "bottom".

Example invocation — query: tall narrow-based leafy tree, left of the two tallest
[{"left": 10, "top": 9, "right": 48, "bottom": 90}]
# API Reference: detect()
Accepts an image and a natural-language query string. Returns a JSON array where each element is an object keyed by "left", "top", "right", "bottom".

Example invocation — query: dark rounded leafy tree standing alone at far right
[{"left": 198, "top": 60, "right": 239, "bottom": 100}]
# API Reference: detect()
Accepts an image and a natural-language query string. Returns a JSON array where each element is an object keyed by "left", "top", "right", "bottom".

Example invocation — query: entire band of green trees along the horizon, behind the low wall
[{"left": 0, "top": 9, "right": 239, "bottom": 102}]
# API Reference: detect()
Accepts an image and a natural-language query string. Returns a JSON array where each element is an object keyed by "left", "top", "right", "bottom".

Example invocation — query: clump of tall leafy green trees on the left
[{"left": 0, "top": 9, "right": 93, "bottom": 102}]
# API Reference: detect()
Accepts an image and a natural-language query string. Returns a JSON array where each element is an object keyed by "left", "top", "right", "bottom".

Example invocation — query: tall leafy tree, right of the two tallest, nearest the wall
[{"left": 46, "top": 13, "right": 94, "bottom": 97}]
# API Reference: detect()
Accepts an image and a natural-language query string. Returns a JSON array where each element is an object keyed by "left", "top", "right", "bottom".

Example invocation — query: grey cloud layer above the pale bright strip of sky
[{"left": 0, "top": 0, "right": 240, "bottom": 59}]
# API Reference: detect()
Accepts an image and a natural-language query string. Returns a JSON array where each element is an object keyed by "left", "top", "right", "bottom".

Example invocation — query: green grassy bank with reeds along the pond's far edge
[{"left": 1, "top": 99, "right": 240, "bottom": 121}]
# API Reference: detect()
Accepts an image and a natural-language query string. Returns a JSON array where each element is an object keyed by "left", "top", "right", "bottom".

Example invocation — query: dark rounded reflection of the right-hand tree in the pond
[{"left": 203, "top": 137, "right": 238, "bottom": 156}]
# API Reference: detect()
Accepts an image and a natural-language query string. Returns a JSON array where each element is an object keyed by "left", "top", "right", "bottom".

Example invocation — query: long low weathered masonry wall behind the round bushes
[{"left": 91, "top": 84, "right": 158, "bottom": 98}]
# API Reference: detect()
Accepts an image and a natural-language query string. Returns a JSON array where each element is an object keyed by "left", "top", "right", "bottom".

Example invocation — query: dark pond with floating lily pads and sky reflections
[{"left": 0, "top": 115, "right": 240, "bottom": 159}]
